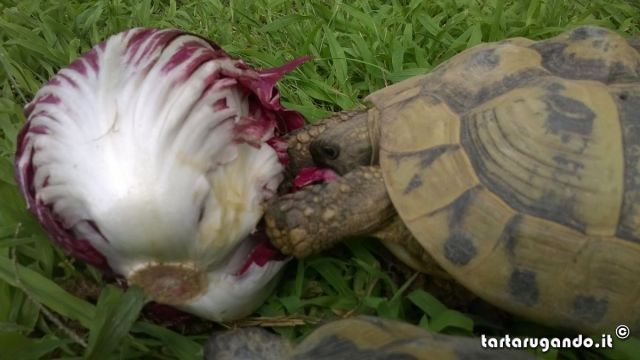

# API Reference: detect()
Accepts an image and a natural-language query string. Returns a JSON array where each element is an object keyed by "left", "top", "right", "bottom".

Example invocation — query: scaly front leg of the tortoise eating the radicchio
[{"left": 265, "top": 166, "right": 396, "bottom": 258}]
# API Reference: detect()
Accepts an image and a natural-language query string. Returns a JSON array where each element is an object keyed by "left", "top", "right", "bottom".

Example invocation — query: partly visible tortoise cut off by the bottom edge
[{"left": 204, "top": 316, "right": 535, "bottom": 360}]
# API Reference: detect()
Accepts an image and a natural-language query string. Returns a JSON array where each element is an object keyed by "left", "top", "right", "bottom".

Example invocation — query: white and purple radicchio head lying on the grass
[{"left": 15, "top": 29, "right": 306, "bottom": 321}]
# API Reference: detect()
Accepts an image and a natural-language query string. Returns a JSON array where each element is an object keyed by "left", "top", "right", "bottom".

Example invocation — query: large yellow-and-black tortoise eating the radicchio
[{"left": 265, "top": 26, "right": 640, "bottom": 333}]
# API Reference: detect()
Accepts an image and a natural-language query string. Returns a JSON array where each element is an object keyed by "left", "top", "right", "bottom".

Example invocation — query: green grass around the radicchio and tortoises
[{"left": 0, "top": 0, "right": 640, "bottom": 359}]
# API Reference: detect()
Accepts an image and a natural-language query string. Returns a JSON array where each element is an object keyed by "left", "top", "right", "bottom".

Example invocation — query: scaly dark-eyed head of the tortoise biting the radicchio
[{"left": 309, "top": 111, "right": 378, "bottom": 175}]
